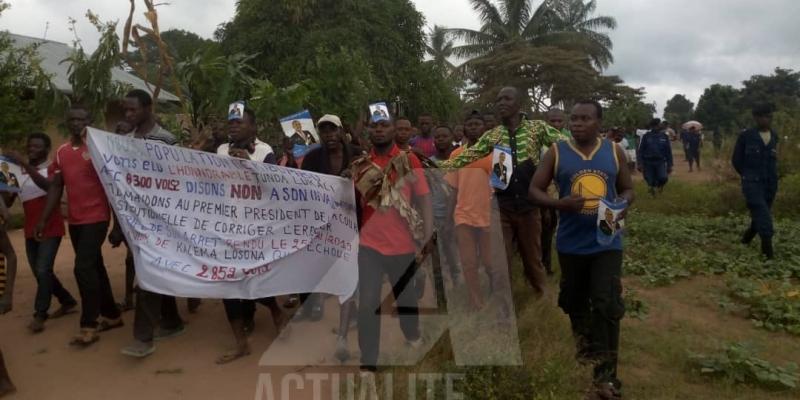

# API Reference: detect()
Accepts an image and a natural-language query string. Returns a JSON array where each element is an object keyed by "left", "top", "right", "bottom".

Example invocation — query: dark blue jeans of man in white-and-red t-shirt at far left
[{"left": 25, "top": 237, "right": 77, "bottom": 319}]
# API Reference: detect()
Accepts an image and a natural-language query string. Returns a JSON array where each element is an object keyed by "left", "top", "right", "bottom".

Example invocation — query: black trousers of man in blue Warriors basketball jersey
[{"left": 558, "top": 251, "right": 625, "bottom": 382}]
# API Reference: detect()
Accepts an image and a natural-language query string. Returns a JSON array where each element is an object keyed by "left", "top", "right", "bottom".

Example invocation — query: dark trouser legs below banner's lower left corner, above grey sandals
[{"left": 133, "top": 288, "right": 183, "bottom": 343}]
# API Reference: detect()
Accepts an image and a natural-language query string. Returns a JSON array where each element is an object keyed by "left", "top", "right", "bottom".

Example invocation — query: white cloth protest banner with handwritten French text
[{"left": 87, "top": 128, "right": 358, "bottom": 301}]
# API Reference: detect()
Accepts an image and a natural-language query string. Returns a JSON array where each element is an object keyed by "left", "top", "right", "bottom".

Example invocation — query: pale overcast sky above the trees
[{"left": 0, "top": 0, "right": 800, "bottom": 115}]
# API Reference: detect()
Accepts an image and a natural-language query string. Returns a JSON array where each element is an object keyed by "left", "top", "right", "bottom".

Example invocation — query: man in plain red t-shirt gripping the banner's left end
[{"left": 34, "top": 106, "right": 123, "bottom": 347}]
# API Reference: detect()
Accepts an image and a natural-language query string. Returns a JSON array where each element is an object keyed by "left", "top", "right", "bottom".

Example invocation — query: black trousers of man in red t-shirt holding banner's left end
[{"left": 69, "top": 221, "right": 120, "bottom": 328}]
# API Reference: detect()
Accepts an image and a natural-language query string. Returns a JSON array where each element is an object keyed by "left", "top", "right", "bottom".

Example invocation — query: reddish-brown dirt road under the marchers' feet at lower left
[{"left": 0, "top": 231, "right": 384, "bottom": 400}]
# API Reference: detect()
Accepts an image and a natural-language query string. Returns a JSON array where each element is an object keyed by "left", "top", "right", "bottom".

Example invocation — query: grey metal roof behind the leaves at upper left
[{"left": 8, "top": 33, "right": 180, "bottom": 102}]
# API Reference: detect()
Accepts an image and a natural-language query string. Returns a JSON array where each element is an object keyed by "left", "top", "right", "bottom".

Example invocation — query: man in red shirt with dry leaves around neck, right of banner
[{"left": 355, "top": 120, "right": 433, "bottom": 372}]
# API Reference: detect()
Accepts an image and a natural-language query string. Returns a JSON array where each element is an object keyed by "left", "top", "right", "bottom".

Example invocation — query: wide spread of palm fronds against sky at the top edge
[{"left": 447, "top": 0, "right": 617, "bottom": 69}]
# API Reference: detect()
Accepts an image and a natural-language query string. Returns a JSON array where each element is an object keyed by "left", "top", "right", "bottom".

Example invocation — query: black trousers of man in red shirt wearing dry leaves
[{"left": 358, "top": 247, "right": 420, "bottom": 371}]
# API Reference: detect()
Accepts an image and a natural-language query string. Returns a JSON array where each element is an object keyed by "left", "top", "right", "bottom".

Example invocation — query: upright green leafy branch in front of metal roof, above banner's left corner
[{"left": 61, "top": 11, "right": 129, "bottom": 122}]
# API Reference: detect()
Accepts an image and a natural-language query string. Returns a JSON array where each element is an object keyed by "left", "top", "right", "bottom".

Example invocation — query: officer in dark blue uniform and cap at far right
[{"left": 732, "top": 105, "right": 778, "bottom": 259}]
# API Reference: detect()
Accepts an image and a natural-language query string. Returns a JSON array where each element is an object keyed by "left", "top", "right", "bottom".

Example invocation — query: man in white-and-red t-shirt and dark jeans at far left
[{"left": 4, "top": 132, "right": 78, "bottom": 333}]
